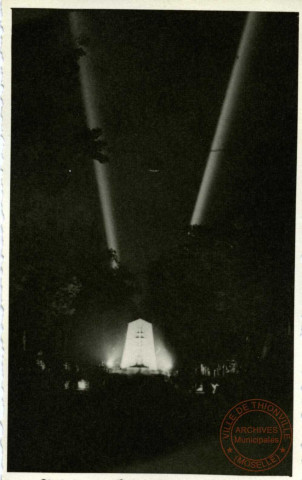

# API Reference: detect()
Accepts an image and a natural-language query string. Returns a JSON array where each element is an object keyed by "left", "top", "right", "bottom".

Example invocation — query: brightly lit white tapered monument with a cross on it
[{"left": 121, "top": 318, "right": 157, "bottom": 373}]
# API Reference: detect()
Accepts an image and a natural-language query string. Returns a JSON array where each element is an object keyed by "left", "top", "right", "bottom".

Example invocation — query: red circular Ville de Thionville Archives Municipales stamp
[{"left": 220, "top": 398, "right": 292, "bottom": 472}]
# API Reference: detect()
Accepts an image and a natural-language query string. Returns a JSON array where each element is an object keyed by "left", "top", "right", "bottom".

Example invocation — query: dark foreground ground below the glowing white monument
[{"left": 8, "top": 368, "right": 291, "bottom": 475}]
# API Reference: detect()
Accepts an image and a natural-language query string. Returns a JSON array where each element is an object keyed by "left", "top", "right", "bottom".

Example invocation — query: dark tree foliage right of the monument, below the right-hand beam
[{"left": 149, "top": 223, "right": 289, "bottom": 370}]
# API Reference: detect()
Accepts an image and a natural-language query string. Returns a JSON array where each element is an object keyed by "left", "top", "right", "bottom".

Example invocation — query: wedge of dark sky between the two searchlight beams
[{"left": 88, "top": 12, "right": 244, "bottom": 268}]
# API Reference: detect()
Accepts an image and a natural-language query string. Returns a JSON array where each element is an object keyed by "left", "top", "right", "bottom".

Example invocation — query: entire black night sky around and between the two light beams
[{"left": 11, "top": 10, "right": 298, "bottom": 360}]
